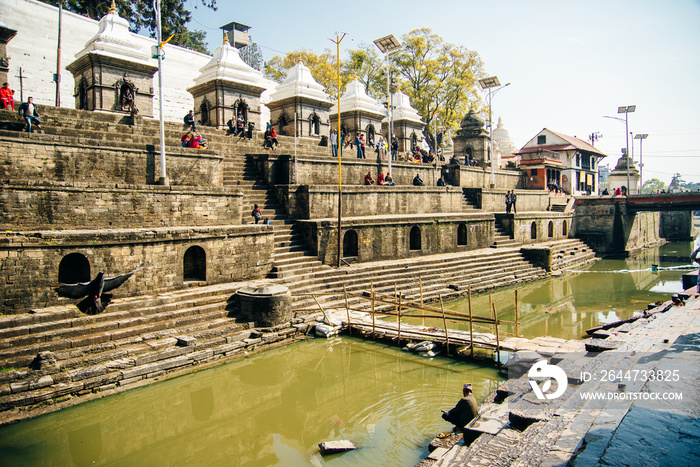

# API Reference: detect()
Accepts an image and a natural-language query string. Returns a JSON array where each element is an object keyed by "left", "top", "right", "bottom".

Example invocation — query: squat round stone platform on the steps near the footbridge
[{"left": 236, "top": 282, "right": 292, "bottom": 327}]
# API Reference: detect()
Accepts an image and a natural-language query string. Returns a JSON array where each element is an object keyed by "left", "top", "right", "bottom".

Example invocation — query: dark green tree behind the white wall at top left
[{"left": 42, "top": 0, "right": 216, "bottom": 53}]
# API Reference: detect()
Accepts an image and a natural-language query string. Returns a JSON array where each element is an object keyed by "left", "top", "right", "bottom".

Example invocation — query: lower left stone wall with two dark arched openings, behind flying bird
[{"left": 0, "top": 225, "right": 274, "bottom": 313}]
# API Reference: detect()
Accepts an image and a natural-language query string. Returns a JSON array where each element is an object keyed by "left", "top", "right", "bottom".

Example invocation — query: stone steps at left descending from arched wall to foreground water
[{"left": 0, "top": 283, "right": 326, "bottom": 424}]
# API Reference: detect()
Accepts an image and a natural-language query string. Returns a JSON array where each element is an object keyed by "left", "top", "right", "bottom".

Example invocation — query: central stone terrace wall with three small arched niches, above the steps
[{"left": 300, "top": 214, "right": 494, "bottom": 265}]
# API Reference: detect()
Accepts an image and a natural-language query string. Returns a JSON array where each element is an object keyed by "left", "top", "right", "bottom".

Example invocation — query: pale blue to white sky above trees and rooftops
[{"left": 186, "top": 0, "right": 700, "bottom": 184}]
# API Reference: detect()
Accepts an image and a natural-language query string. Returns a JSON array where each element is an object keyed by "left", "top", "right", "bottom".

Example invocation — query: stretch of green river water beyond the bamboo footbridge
[{"left": 406, "top": 242, "right": 693, "bottom": 339}]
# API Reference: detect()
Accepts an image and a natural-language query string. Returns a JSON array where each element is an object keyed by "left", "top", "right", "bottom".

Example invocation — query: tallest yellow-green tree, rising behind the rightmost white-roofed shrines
[{"left": 394, "top": 28, "right": 483, "bottom": 148}]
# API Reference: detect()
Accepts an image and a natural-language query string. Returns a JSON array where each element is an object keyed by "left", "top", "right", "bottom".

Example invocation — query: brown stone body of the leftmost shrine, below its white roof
[{"left": 66, "top": 53, "right": 158, "bottom": 117}]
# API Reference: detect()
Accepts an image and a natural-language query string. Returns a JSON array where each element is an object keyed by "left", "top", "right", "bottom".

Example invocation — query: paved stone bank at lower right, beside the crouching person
[{"left": 418, "top": 295, "right": 700, "bottom": 467}]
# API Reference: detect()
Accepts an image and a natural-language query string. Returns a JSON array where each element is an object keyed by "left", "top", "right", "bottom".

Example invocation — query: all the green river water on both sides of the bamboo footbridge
[{"left": 0, "top": 242, "right": 693, "bottom": 466}]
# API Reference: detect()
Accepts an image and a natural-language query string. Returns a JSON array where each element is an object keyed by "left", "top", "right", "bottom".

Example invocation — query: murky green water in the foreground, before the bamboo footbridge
[{"left": 0, "top": 337, "right": 499, "bottom": 467}]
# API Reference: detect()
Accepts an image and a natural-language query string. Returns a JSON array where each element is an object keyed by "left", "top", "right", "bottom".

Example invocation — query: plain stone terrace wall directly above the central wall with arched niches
[{"left": 275, "top": 185, "right": 463, "bottom": 219}]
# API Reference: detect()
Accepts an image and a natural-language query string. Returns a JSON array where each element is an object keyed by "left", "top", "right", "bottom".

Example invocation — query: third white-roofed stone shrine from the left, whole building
[{"left": 266, "top": 60, "right": 333, "bottom": 139}]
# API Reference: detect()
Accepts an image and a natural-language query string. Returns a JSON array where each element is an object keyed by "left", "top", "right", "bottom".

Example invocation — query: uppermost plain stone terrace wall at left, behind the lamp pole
[{"left": 0, "top": 138, "right": 223, "bottom": 187}]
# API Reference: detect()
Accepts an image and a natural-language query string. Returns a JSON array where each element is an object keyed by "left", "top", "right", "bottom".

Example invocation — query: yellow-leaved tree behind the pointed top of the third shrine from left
[{"left": 264, "top": 49, "right": 348, "bottom": 100}]
